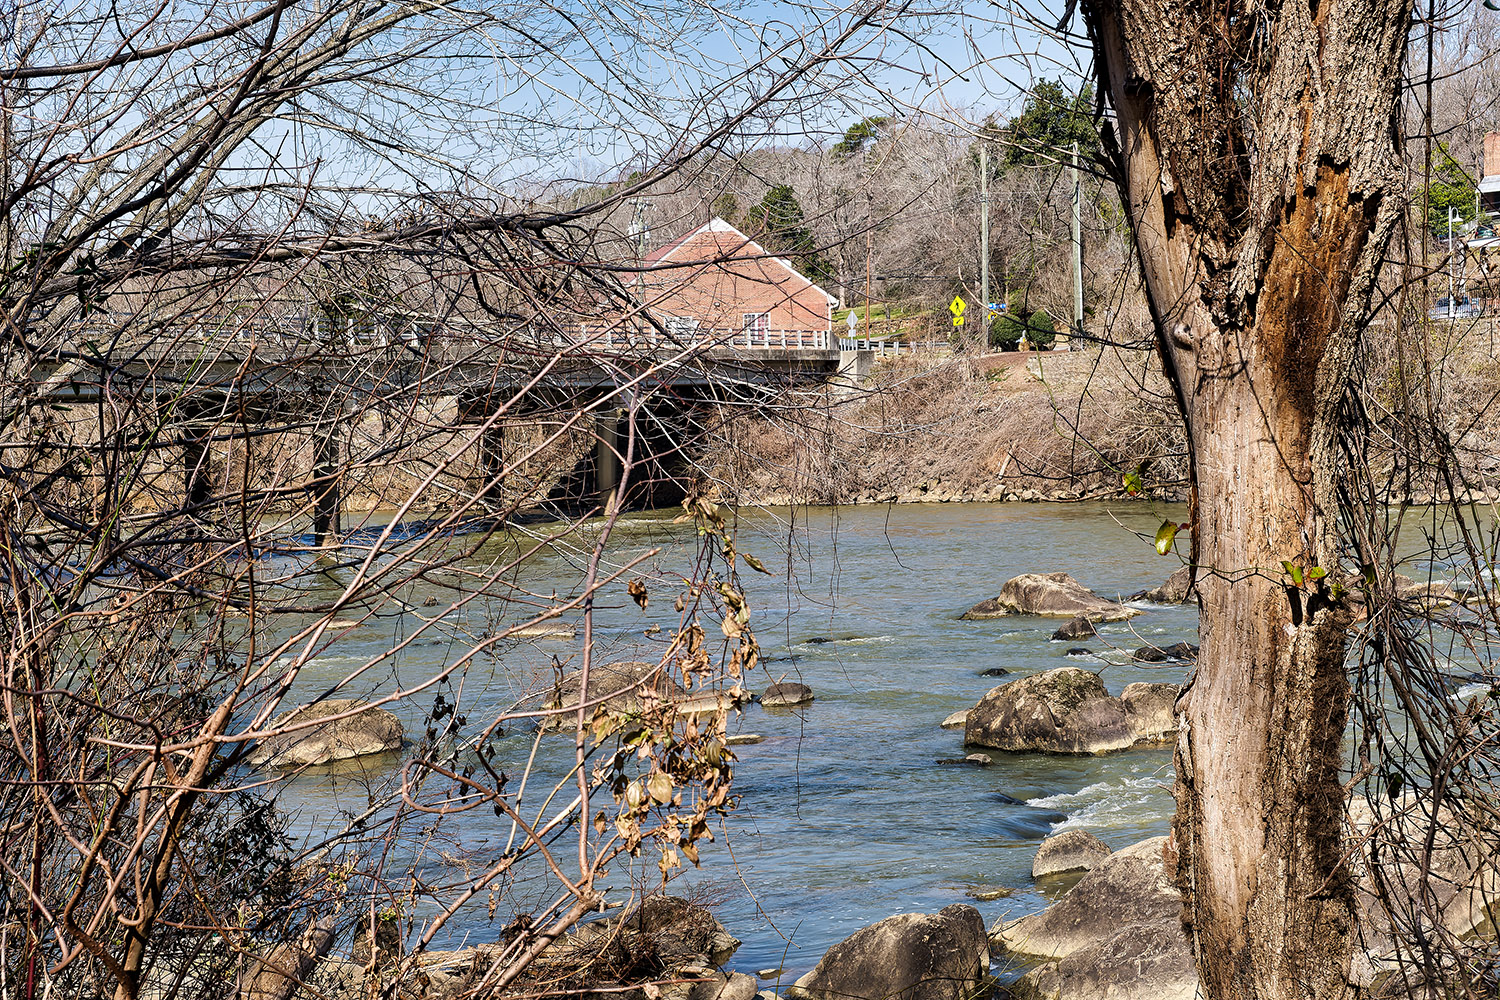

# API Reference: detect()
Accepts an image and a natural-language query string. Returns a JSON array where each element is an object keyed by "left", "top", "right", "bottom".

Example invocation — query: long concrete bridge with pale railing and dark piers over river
[{"left": 20, "top": 313, "right": 879, "bottom": 544}]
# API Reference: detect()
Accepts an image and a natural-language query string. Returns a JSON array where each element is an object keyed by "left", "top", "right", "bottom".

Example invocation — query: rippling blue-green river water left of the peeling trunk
[{"left": 258, "top": 502, "right": 1197, "bottom": 985}]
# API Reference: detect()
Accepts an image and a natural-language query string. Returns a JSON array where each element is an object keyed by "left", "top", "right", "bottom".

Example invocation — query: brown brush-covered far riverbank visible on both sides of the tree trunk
[{"left": 701, "top": 335, "right": 1500, "bottom": 507}]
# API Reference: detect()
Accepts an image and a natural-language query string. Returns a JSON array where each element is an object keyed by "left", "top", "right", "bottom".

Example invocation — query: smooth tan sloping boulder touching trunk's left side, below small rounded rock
[{"left": 990, "top": 837, "right": 1182, "bottom": 958}]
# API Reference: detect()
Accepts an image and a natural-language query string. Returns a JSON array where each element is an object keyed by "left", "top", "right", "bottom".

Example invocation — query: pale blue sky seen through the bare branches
[{"left": 11, "top": 0, "right": 1080, "bottom": 227}]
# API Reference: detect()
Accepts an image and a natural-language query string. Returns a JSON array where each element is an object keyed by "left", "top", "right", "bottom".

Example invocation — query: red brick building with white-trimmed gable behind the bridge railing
[{"left": 642, "top": 217, "right": 836, "bottom": 348}]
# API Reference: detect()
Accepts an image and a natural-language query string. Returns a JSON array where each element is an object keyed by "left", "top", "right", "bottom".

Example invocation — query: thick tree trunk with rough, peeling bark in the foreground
[{"left": 1083, "top": 0, "right": 1410, "bottom": 1000}]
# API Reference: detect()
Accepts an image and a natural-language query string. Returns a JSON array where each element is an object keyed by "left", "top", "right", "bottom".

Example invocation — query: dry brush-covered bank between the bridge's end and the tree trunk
[{"left": 702, "top": 340, "right": 1185, "bottom": 504}]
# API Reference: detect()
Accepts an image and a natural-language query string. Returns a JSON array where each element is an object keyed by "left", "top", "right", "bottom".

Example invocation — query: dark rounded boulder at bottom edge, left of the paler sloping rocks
[{"left": 786, "top": 903, "right": 990, "bottom": 1000}]
